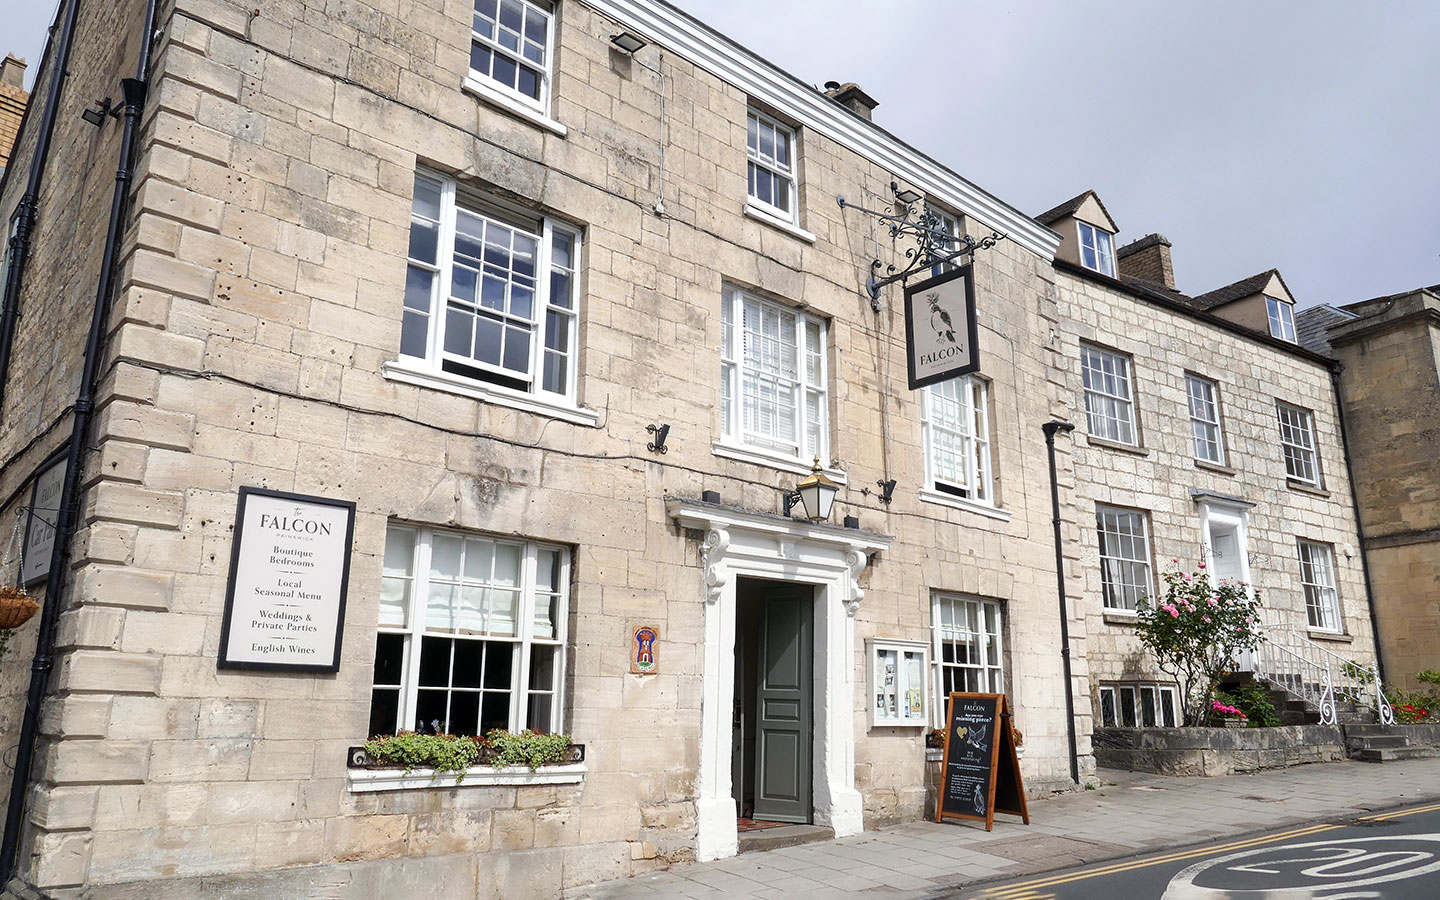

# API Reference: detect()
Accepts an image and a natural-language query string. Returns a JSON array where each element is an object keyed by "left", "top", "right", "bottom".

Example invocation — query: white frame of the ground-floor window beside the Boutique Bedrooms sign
[{"left": 372, "top": 521, "right": 570, "bottom": 733}]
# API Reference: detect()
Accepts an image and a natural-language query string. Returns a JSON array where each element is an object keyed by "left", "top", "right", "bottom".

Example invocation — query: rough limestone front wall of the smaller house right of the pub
[{"left": 1060, "top": 274, "right": 1374, "bottom": 708}]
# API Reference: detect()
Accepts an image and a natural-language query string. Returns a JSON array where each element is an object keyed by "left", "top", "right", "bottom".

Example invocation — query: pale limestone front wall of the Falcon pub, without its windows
[{"left": 0, "top": 0, "right": 1090, "bottom": 896}]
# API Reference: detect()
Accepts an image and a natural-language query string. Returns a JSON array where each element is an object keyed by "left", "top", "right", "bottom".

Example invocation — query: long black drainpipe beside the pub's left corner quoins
[{"left": 0, "top": 0, "right": 157, "bottom": 886}]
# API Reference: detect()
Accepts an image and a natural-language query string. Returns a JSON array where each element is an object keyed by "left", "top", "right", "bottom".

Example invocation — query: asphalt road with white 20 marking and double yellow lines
[{"left": 943, "top": 804, "right": 1440, "bottom": 900}]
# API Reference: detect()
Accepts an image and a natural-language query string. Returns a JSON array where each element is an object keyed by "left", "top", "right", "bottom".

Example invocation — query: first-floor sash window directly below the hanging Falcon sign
[{"left": 923, "top": 376, "right": 994, "bottom": 503}]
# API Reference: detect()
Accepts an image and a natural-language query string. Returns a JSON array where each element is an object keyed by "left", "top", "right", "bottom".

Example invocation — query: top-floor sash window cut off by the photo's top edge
[{"left": 469, "top": 0, "right": 554, "bottom": 111}]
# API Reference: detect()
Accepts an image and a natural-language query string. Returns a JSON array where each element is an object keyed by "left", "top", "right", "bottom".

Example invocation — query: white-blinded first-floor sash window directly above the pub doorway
[{"left": 720, "top": 288, "right": 828, "bottom": 464}]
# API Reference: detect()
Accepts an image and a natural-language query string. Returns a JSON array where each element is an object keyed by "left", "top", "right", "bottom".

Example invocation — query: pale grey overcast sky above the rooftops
[{"left": 0, "top": 0, "right": 1440, "bottom": 305}]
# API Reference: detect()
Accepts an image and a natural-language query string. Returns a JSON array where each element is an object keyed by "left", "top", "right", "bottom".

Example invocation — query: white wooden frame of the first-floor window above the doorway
[{"left": 719, "top": 285, "right": 829, "bottom": 471}]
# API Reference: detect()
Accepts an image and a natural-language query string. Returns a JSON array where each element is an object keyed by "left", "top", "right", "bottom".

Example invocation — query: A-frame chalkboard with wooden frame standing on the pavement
[{"left": 935, "top": 693, "right": 1030, "bottom": 831}]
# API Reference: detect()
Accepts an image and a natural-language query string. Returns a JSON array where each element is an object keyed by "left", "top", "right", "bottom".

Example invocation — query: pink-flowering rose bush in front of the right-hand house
[{"left": 1136, "top": 560, "right": 1264, "bottom": 726}]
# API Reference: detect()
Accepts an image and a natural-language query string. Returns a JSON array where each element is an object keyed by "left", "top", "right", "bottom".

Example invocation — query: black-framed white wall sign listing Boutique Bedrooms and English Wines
[{"left": 219, "top": 487, "right": 356, "bottom": 672}]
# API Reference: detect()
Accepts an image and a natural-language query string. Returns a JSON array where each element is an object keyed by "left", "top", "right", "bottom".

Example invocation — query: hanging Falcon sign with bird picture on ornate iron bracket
[{"left": 904, "top": 265, "right": 981, "bottom": 390}]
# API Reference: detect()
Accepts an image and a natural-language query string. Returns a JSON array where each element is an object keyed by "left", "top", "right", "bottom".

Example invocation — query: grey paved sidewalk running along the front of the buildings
[{"left": 566, "top": 759, "right": 1440, "bottom": 900}]
